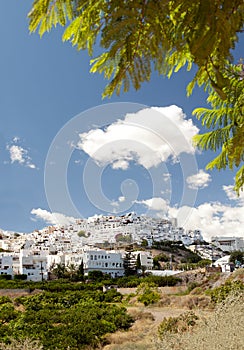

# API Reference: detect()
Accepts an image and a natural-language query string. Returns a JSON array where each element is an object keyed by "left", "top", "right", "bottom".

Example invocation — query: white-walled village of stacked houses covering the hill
[{"left": 0, "top": 213, "right": 243, "bottom": 281}]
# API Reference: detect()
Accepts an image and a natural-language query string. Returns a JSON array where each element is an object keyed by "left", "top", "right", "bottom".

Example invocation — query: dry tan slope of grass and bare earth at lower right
[{"left": 103, "top": 269, "right": 244, "bottom": 350}]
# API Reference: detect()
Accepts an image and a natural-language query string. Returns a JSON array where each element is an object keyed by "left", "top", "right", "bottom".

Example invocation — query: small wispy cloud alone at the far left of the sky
[{"left": 6, "top": 137, "right": 36, "bottom": 169}]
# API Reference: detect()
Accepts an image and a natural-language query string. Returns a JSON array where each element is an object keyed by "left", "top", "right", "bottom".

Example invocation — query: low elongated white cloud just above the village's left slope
[{"left": 31, "top": 208, "right": 76, "bottom": 225}]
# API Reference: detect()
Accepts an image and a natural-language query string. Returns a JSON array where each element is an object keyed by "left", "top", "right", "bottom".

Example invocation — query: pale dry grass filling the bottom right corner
[{"left": 153, "top": 294, "right": 244, "bottom": 350}]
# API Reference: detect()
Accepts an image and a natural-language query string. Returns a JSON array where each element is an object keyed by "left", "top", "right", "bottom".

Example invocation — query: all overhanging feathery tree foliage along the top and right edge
[{"left": 29, "top": 0, "right": 244, "bottom": 193}]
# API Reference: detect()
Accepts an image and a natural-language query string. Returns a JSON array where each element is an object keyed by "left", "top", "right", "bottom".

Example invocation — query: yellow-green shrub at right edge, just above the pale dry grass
[{"left": 208, "top": 281, "right": 244, "bottom": 303}]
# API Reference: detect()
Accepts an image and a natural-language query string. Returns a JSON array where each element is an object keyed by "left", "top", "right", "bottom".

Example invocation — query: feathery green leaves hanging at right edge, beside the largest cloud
[{"left": 193, "top": 63, "right": 244, "bottom": 193}]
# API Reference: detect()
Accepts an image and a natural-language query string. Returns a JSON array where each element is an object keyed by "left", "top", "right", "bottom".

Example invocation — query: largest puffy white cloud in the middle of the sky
[{"left": 77, "top": 105, "right": 199, "bottom": 169}]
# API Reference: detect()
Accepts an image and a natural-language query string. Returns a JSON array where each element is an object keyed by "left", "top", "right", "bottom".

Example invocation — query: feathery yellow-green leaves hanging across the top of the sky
[{"left": 29, "top": 0, "right": 244, "bottom": 96}]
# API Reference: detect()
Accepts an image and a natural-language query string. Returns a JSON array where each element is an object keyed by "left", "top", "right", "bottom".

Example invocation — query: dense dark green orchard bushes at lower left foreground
[{"left": 0, "top": 290, "right": 133, "bottom": 350}]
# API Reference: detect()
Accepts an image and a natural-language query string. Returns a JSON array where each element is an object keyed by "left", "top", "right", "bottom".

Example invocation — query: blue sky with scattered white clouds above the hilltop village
[{"left": 0, "top": 0, "right": 244, "bottom": 238}]
